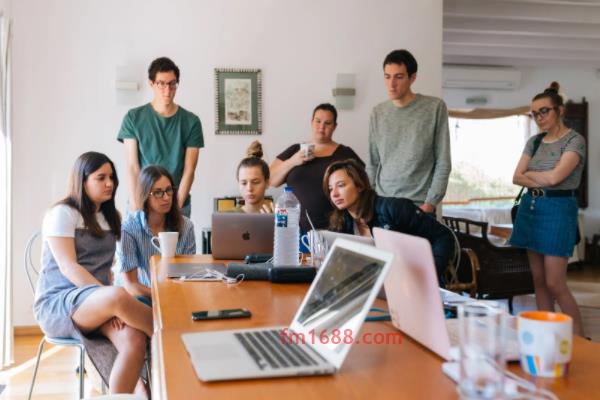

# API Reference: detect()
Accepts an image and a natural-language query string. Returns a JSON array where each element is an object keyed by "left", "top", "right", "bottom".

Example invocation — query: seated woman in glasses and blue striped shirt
[{"left": 115, "top": 165, "right": 196, "bottom": 305}]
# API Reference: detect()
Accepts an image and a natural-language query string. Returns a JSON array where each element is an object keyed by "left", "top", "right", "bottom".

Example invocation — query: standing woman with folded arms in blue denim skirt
[{"left": 510, "top": 82, "right": 586, "bottom": 335}]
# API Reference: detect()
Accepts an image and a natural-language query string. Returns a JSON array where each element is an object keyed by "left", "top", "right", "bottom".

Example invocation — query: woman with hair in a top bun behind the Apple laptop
[{"left": 233, "top": 140, "right": 273, "bottom": 214}]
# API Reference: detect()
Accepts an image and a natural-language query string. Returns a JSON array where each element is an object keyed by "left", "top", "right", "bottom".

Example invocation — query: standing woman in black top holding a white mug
[{"left": 271, "top": 103, "right": 364, "bottom": 232}]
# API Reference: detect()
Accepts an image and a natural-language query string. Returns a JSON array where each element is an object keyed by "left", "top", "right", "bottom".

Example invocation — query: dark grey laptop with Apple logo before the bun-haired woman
[{"left": 211, "top": 212, "right": 275, "bottom": 260}]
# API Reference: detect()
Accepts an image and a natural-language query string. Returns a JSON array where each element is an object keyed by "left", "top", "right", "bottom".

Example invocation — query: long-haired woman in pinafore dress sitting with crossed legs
[{"left": 34, "top": 152, "right": 153, "bottom": 393}]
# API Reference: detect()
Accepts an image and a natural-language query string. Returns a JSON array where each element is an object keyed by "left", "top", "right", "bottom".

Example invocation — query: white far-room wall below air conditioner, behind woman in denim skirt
[{"left": 443, "top": 67, "right": 600, "bottom": 236}]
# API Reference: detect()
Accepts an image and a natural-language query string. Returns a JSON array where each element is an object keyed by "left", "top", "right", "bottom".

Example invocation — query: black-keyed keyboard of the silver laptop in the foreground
[{"left": 234, "top": 329, "right": 325, "bottom": 370}]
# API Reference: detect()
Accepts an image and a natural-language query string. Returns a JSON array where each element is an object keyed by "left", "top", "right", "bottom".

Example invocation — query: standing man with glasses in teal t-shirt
[{"left": 117, "top": 57, "right": 204, "bottom": 217}]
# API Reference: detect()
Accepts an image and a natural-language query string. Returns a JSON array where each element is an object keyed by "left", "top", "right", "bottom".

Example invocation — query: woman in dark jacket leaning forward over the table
[{"left": 323, "top": 160, "right": 454, "bottom": 284}]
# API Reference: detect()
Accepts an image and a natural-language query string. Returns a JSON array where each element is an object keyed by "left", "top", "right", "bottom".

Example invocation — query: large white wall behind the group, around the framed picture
[{"left": 12, "top": 0, "right": 442, "bottom": 325}]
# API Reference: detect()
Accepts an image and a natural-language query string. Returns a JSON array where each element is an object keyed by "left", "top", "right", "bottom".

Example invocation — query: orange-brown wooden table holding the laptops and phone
[{"left": 151, "top": 255, "right": 600, "bottom": 400}]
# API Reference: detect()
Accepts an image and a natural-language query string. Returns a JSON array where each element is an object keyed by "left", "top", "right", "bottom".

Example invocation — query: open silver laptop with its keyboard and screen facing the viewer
[{"left": 181, "top": 240, "right": 393, "bottom": 381}]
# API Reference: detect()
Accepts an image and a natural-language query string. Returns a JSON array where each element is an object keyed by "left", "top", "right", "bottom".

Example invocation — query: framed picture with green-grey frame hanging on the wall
[{"left": 215, "top": 68, "right": 262, "bottom": 135}]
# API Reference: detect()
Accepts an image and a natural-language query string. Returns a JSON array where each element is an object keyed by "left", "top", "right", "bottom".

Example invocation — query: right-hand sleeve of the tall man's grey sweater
[{"left": 425, "top": 102, "right": 452, "bottom": 206}]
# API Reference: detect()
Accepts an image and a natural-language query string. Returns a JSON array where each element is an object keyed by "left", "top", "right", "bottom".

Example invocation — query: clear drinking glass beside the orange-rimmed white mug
[{"left": 458, "top": 302, "right": 508, "bottom": 399}]
